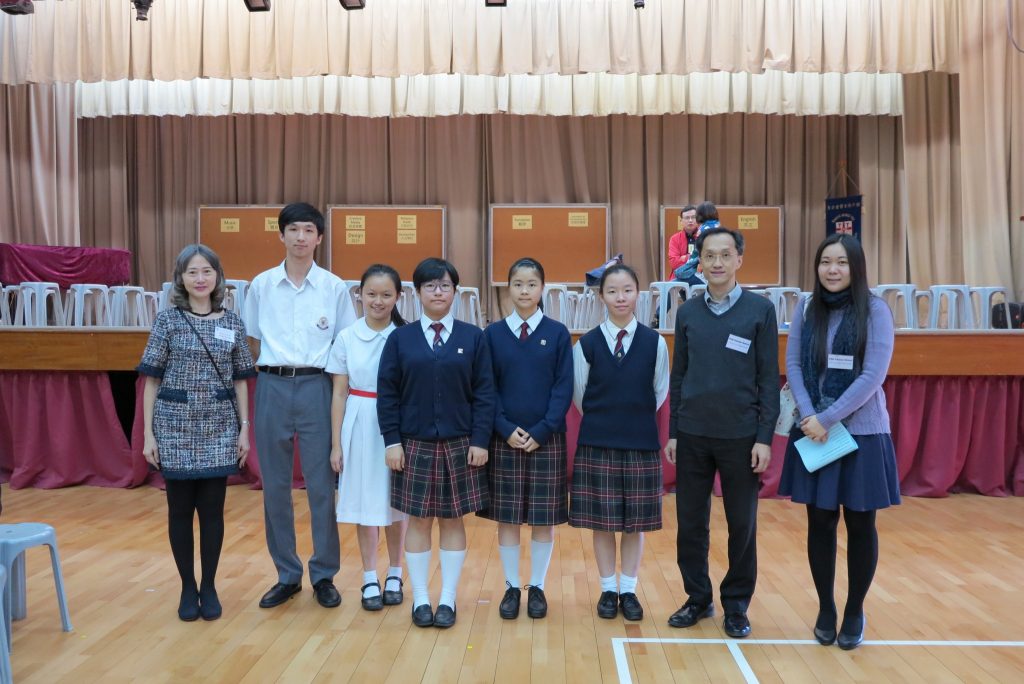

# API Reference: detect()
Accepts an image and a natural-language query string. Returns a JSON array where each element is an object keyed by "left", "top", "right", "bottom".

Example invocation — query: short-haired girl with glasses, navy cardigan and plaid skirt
[{"left": 377, "top": 258, "right": 495, "bottom": 628}]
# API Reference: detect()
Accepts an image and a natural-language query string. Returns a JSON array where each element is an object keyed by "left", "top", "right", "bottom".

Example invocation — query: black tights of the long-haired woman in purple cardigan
[{"left": 807, "top": 506, "right": 879, "bottom": 629}]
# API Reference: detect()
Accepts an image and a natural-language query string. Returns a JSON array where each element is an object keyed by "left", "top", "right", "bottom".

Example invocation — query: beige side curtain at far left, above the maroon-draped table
[{"left": 0, "top": 84, "right": 79, "bottom": 245}]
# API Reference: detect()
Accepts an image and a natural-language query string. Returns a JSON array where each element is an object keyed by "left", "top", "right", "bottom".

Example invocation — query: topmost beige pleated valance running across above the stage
[{"left": 0, "top": 0, "right": 958, "bottom": 83}]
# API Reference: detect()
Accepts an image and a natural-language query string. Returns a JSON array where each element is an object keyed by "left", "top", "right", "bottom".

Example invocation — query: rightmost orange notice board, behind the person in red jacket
[{"left": 662, "top": 205, "right": 782, "bottom": 286}]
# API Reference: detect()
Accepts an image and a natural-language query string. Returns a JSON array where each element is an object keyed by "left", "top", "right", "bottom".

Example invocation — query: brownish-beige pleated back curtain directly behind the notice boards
[{"left": 79, "top": 114, "right": 905, "bottom": 321}]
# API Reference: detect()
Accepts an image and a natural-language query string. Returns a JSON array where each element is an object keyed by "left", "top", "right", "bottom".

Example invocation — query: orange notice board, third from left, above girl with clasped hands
[{"left": 487, "top": 204, "right": 611, "bottom": 286}]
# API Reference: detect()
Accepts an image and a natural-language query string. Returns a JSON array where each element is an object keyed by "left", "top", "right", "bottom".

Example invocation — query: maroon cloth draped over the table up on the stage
[{"left": 0, "top": 243, "right": 131, "bottom": 290}]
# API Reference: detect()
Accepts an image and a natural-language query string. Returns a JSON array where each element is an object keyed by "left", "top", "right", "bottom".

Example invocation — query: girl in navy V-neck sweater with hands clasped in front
[{"left": 478, "top": 258, "right": 572, "bottom": 619}]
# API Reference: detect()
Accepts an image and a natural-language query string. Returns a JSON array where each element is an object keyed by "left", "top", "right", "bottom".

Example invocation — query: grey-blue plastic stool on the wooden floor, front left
[{"left": 0, "top": 522, "right": 72, "bottom": 650}]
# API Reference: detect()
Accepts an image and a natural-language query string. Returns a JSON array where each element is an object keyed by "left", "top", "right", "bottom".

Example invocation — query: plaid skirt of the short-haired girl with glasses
[{"left": 391, "top": 437, "right": 487, "bottom": 518}]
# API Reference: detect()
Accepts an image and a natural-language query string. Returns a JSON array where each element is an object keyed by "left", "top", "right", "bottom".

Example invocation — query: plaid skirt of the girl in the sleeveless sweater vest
[{"left": 569, "top": 444, "right": 662, "bottom": 532}]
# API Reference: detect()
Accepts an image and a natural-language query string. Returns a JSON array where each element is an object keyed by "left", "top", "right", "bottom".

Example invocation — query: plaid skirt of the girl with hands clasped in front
[{"left": 477, "top": 433, "right": 569, "bottom": 525}]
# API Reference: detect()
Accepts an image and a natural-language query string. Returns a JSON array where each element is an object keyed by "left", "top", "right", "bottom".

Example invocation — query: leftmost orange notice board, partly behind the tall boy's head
[{"left": 198, "top": 205, "right": 285, "bottom": 281}]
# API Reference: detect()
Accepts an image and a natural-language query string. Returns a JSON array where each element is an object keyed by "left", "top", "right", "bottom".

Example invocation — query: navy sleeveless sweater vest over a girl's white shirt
[{"left": 580, "top": 326, "right": 660, "bottom": 452}]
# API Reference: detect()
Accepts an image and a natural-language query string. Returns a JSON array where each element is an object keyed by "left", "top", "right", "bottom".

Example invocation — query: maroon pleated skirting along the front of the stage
[{"left": 0, "top": 371, "right": 1024, "bottom": 497}]
